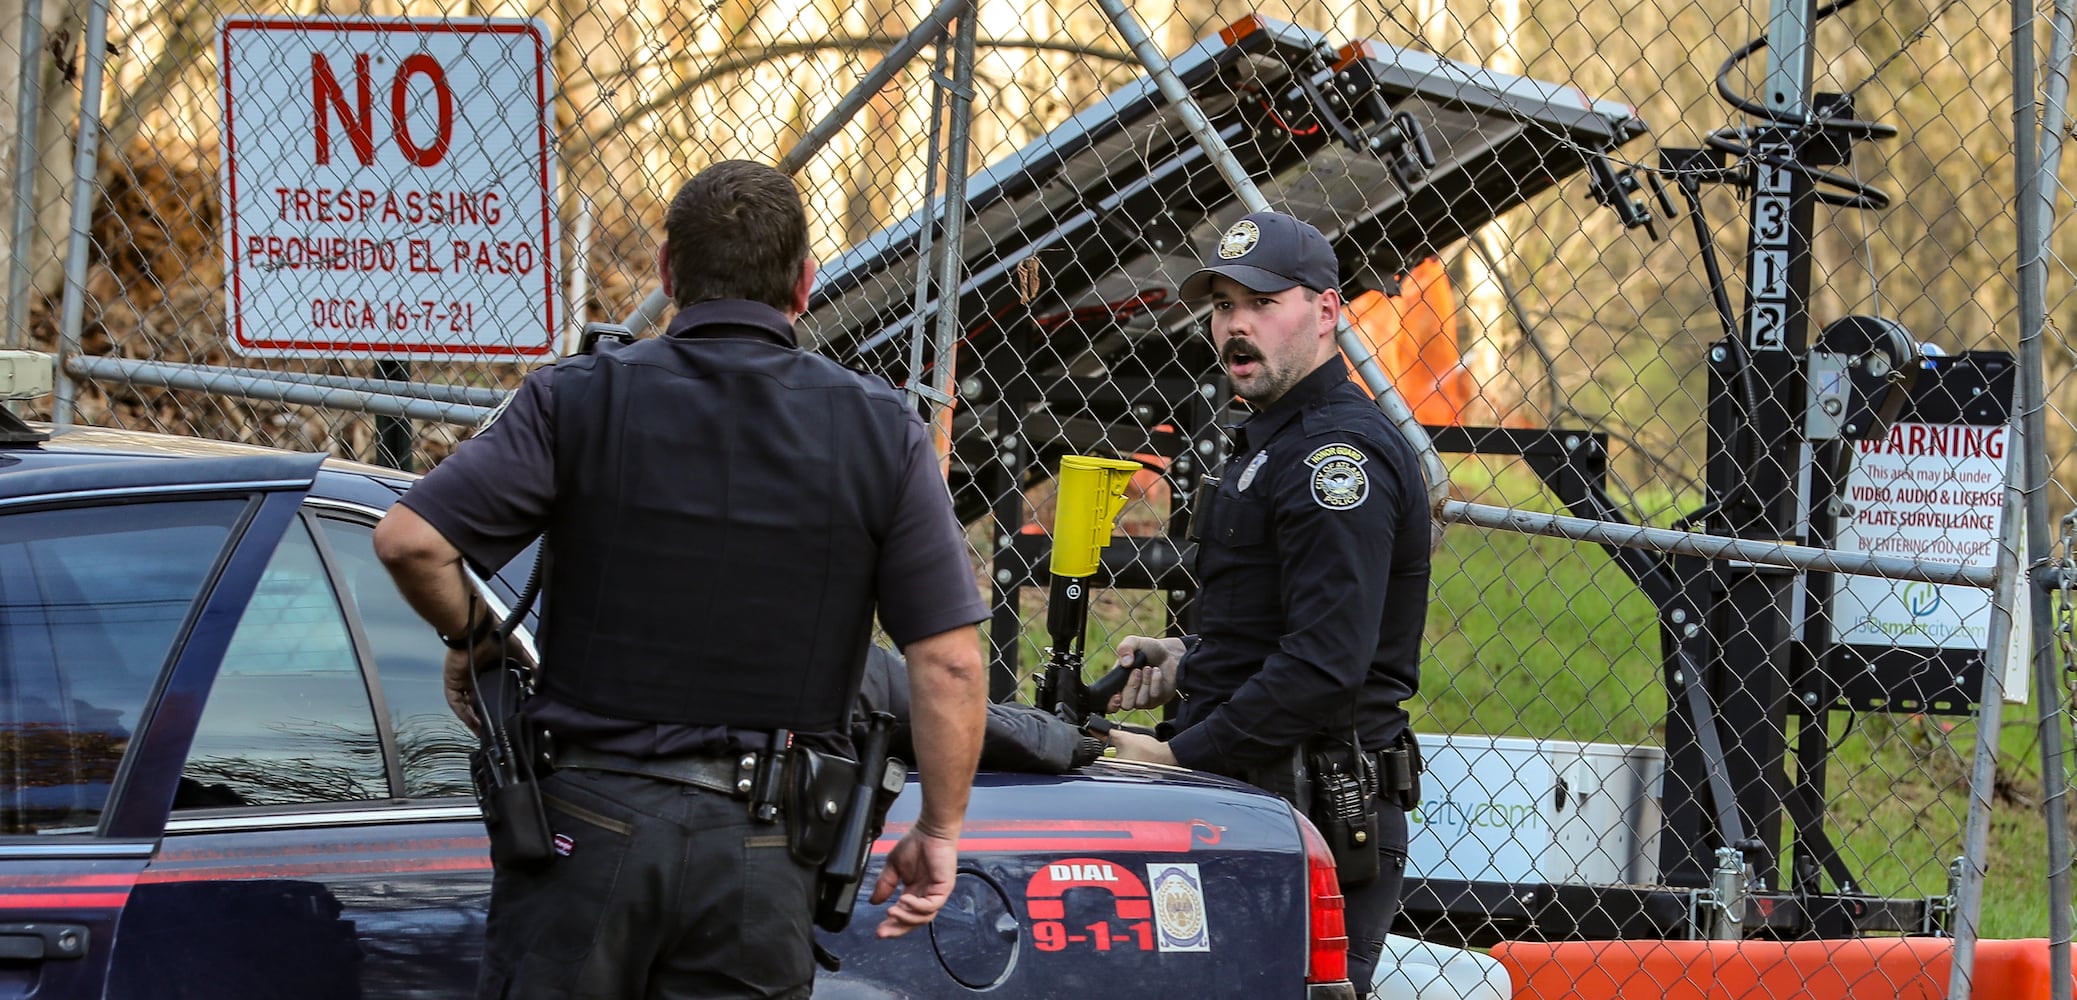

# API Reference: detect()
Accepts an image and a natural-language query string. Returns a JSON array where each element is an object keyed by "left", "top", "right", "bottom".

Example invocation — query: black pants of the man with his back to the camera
[{"left": 478, "top": 769, "right": 814, "bottom": 1000}]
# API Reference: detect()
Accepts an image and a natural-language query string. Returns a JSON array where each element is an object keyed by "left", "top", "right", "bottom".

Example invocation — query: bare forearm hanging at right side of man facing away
[{"left": 901, "top": 626, "right": 989, "bottom": 838}]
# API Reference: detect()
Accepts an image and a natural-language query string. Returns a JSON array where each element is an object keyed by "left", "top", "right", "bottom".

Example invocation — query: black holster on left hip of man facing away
[{"left": 469, "top": 661, "right": 555, "bottom": 869}]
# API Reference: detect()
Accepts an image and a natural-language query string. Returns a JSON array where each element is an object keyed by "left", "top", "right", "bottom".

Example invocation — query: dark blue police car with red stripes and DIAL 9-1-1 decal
[{"left": 0, "top": 370, "right": 1354, "bottom": 1000}]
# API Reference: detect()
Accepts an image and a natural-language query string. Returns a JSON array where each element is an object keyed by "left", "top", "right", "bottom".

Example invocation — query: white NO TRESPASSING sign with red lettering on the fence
[{"left": 220, "top": 17, "right": 561, "bottom": 358}]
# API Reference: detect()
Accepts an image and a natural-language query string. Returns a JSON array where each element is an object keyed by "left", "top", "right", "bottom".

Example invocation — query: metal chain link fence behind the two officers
[{"left": 12, "top": 0, "right": 2077, "bottom": 996}]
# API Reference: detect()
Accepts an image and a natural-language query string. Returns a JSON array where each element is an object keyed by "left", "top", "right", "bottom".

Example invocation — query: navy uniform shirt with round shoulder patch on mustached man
[{"left": 1169, "top": 356, "right": 1429, "bottom": 775}]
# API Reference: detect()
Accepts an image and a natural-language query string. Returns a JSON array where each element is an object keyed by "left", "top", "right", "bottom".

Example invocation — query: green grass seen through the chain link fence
[{"left": 1024, "top": 462, "right": 2048, "bottom": 938}]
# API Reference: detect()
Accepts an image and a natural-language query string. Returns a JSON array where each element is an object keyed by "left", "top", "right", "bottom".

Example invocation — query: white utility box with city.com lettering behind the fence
[{"left": 1406, "top": 734, "right": 1666, "bottom": 886}]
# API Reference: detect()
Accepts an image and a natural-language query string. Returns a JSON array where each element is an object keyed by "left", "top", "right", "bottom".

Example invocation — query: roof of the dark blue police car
[{"left": 0, "top": 424, "right": 417, "bottom": 507}]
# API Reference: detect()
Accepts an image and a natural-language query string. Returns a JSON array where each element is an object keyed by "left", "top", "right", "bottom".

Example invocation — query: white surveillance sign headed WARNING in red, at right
[{"left": 1832, "top": 422, "right": 2011, "bottom": 651}]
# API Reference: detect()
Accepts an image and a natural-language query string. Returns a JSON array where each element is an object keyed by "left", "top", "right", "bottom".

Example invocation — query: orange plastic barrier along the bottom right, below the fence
[{"left": 1491, "top": 938, "right": 2048, "bottom": 1000}]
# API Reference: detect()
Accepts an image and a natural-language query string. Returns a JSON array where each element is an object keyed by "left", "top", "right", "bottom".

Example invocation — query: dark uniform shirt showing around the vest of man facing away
[{"left": 401, "top": 299, "right": 989, "bottom": 757}]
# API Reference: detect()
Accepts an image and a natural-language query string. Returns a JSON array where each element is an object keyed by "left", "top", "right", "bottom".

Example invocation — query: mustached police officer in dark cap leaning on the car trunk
[{"left": 1111, "top": 212, "right": 1429, "bottom": 992}]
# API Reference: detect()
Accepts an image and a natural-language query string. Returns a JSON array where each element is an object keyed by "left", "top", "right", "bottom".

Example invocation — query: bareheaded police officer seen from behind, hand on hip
[{"left": 376, "top": 160, "right": 989, "bottom": 998}]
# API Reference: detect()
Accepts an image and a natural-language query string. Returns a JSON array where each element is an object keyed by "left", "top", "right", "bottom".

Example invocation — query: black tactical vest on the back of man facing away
[{"left": 542, "top": 311, "right": 916, "bottom": 732}]
